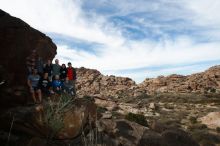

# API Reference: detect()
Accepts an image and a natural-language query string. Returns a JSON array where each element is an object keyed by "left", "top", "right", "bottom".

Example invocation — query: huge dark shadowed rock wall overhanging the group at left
[{"left": 0, "top": 10, "right": 57, "bottom": 104}]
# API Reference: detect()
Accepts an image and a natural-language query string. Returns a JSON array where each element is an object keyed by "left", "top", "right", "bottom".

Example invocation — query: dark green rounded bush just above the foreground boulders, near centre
[{"left": 125, "top": 113, "right": 148, "bottom": 126}]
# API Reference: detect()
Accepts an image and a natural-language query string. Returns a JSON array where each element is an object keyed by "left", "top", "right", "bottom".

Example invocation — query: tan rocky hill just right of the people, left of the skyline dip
[{"left": 76, "top": 67, "right": 136, "bottom": 98}]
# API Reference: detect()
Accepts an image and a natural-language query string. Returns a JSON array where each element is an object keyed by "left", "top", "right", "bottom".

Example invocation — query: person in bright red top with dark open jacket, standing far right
[{"left": 67, "top": 62, "right": 76, "bottom": 95}]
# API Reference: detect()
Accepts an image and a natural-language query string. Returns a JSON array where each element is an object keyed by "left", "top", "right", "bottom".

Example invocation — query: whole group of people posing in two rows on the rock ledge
[{"left": 27, "top": 58, "right": 76, "bottom": 103}]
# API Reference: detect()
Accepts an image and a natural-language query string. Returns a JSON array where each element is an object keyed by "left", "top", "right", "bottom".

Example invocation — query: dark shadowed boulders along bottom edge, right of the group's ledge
[{"left": 96, "top": 119, "right": 199, "bottom": 146}]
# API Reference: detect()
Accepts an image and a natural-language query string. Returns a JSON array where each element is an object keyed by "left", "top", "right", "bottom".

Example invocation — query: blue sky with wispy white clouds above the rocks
[{"left": 0, "top": 0, "right": 220, "bottom": 83}]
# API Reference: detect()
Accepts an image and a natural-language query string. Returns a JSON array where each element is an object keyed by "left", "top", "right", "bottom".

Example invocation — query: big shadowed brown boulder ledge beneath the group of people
[{"left": 0, "top": 98, "right": 97, "bottom": 143}]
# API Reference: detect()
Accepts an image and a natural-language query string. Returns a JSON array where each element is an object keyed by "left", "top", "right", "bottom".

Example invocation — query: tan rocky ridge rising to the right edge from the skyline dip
[{"left": 138, "top": 66, "right": 220, "bottom": 93}]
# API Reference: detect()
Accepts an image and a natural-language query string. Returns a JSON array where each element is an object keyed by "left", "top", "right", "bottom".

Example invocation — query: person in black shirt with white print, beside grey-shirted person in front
[{"left": 39, "top": 73, "right": 51, "bottom": 95}]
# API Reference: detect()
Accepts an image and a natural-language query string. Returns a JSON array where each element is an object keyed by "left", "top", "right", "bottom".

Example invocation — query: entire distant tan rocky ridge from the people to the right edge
[{"left": 77, "top": 66, "right": 220, "bottom": 98}]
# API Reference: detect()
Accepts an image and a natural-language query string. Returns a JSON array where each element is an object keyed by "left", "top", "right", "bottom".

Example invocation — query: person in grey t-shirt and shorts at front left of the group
[{"left": 27, "top": 69, "right": 42, "bottom": 103}]
